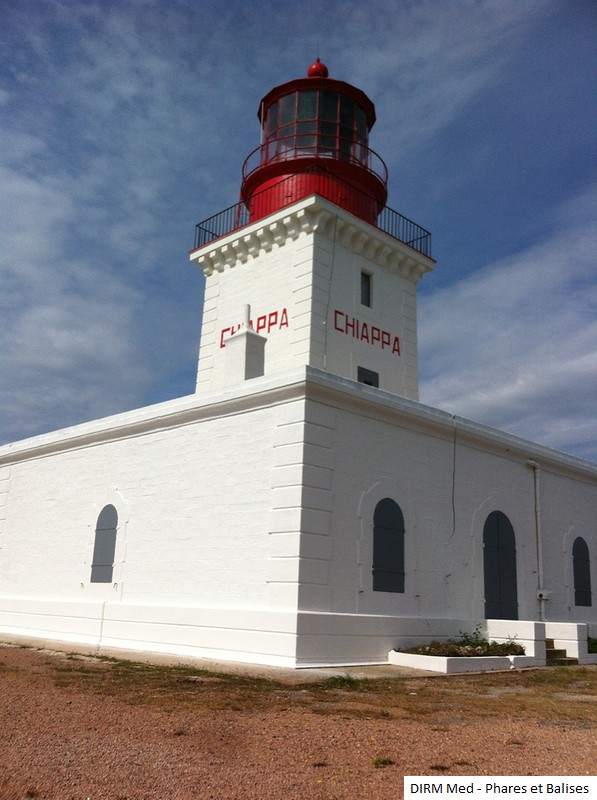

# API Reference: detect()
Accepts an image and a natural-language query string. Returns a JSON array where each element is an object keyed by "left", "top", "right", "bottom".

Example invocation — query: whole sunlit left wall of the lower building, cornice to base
[{"left": 0, "top": 378, "right": 314, "bottom": 664}]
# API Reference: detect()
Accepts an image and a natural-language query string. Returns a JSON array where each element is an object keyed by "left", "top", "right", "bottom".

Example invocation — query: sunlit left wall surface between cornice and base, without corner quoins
[{"left": 2, "top": 409, "right": 275, "bottom": 605}]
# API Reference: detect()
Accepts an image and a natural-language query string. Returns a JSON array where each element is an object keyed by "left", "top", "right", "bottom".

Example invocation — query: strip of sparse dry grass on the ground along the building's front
[{"left": 33, "top": 644, "right": 597, "bottom": 724}]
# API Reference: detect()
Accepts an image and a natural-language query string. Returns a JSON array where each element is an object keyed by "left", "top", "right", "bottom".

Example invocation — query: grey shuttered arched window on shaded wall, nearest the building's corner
[{"left": 373, "top": 497, "right": 404, "bottom": 592}]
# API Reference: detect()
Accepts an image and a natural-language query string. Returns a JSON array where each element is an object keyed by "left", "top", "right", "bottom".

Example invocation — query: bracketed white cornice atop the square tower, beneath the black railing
[{"left": 190, "top": 195, "right": 435, "bottom": 284}]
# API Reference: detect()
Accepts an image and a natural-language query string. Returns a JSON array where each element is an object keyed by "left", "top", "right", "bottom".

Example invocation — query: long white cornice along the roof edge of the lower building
[{"left": 0, "top": 366, "right": 597, "bottom": 485}]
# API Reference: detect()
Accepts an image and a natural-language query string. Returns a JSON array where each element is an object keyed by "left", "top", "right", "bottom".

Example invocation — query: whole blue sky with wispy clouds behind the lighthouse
[{"left": 0, "top": 0, "right": 597, "bottom": 460}]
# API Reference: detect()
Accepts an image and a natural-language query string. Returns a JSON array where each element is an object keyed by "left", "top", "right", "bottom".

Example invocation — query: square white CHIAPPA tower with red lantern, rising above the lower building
[{"left": 190, "top": 59, "right": 435, "bottom": 400}]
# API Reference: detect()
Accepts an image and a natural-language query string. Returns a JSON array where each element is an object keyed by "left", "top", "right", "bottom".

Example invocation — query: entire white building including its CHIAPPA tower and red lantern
[{"left": 0, "top": 61, "right": 597, "bottom": 667}]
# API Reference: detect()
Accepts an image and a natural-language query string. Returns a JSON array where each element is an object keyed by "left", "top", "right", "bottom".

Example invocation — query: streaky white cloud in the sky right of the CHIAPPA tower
[{"left": 419, "top": 187, "right": 597, "bottom": 458}]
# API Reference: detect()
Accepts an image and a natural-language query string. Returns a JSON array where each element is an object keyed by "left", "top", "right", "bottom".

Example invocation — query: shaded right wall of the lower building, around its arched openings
[{"left": 301, "top": 372, "right": 597, "bottom": 622}]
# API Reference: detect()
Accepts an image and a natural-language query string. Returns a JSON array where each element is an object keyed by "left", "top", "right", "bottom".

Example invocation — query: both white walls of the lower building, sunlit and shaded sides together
[{"left": 0, "top": 368, "right": 597, "bottom": 666}]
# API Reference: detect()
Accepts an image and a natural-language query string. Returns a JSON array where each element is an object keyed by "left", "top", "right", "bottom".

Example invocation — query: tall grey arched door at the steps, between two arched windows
[{"left": 483, "top": 511, "right": 518, "bottom": 619}]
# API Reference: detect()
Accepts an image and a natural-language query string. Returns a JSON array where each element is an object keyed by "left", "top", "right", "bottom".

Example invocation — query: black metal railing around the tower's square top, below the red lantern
[{"left": 195, "top": 173, "right": 431, "bottom": 258}]
